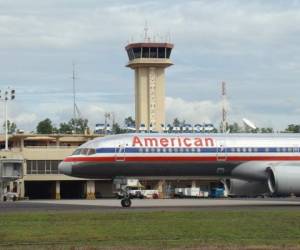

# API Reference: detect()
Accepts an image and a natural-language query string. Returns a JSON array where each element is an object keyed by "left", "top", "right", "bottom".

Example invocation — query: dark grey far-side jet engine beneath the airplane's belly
[{"left": 223, "top": 179, "right": 269, "bottom": 197}]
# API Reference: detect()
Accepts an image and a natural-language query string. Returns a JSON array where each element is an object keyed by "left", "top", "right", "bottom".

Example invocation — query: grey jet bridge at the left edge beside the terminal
[{"left": 0, "top": 158, "right": 23, "bottom": 201}]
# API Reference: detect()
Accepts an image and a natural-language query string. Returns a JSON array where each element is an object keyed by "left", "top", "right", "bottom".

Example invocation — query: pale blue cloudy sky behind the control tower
[{"left": 0, "top": 0, "right": 300, "bottom": 131}]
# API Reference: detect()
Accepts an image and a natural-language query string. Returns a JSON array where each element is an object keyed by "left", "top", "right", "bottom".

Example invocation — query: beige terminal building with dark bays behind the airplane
[{"left": 0, "top": 134, "right": 218, "bottom": 199}]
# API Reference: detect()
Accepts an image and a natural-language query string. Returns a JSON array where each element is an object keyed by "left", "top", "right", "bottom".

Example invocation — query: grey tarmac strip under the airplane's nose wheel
[{"left": 0, "top": 198, "right": 300, "bottom": 213}]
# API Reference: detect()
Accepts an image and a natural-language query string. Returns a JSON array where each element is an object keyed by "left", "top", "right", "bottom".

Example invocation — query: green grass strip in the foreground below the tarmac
[{"left": 0, "top": 210, "right": 300, "bottom": 249}]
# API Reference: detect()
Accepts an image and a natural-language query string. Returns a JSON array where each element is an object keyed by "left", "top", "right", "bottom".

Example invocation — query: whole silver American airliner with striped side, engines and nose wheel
[{"left": 59, "top": 134, "right": 300, "bottom": 207}]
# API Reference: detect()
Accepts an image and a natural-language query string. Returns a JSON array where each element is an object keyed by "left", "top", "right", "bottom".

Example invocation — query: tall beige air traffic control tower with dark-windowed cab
[{"left": 125, "top": 39, "right": 174, "bottom": 131}]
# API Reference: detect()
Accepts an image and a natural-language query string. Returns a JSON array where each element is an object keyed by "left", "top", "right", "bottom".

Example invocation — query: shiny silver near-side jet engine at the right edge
[{"left": 267, "top": 163, "right": 300, "bottom": 196}]
